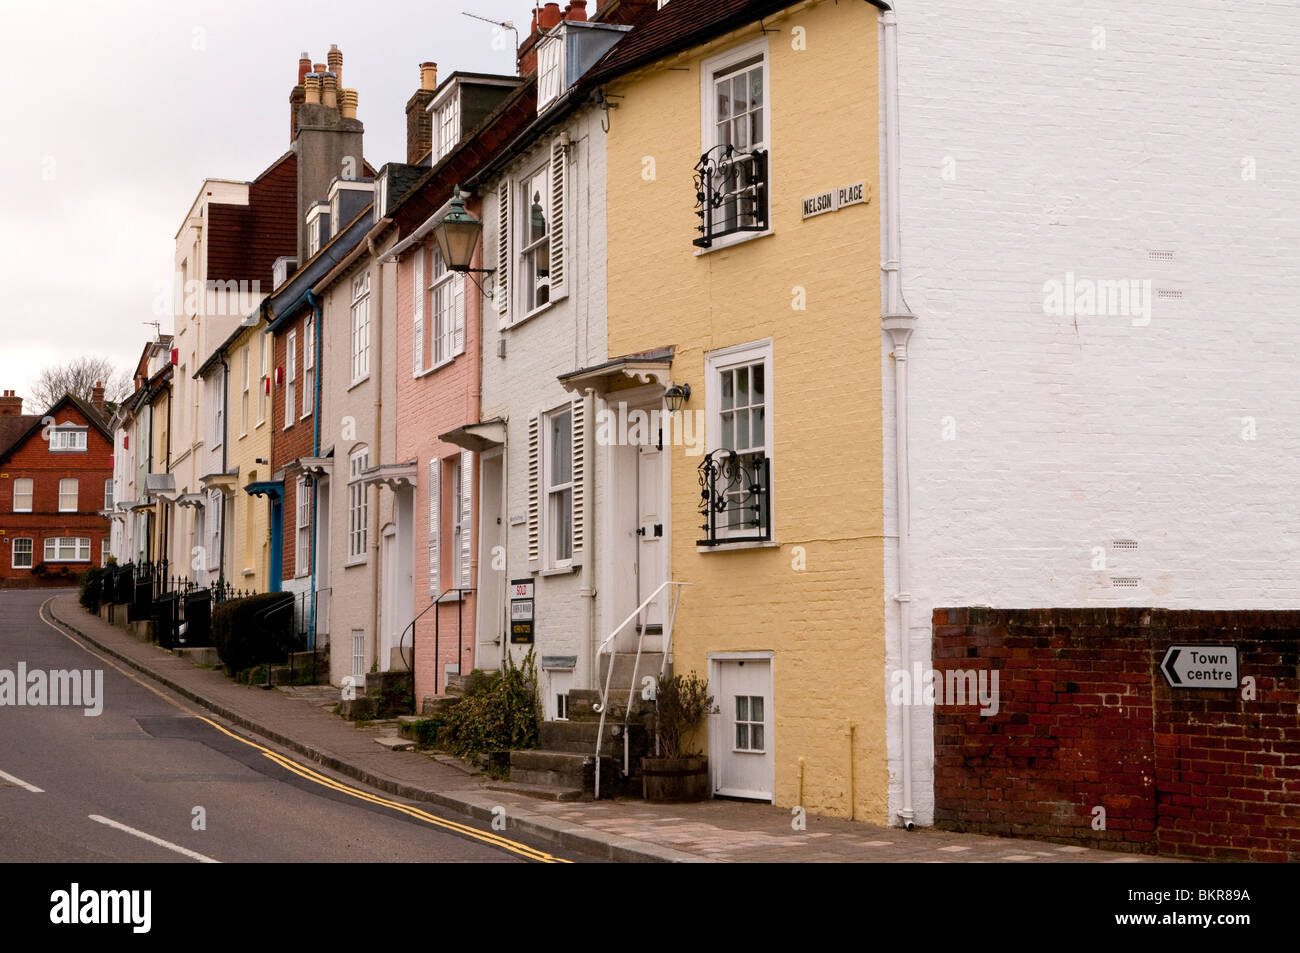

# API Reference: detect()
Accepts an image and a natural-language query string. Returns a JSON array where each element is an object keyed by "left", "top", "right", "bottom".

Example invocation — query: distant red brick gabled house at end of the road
[{"left": 0, "top": 390, "right": 113, "bottom": 589}]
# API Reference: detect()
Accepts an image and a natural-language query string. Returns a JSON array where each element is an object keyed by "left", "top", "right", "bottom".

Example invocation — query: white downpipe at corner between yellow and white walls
[{"left": 880, "top": 10, "right": 917, "bottom": 831}]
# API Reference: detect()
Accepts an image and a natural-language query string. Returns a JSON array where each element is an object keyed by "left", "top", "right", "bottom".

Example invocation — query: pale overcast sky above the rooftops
[{"left": 0, "top": 0, "right": 532, "bottom": 413}]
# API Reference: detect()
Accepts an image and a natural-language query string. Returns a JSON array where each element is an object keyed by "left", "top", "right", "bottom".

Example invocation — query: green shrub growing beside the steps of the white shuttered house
[{"left": 439, "top": 650, "right": 541, "bottom": 758}]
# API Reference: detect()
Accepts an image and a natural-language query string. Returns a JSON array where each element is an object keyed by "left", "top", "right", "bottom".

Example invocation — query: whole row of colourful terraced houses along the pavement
[{"left": 104, "top": 0, "right": 1300, "bottom": 857}]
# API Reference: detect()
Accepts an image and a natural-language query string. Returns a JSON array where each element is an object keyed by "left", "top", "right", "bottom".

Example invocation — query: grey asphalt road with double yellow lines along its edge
[{"left": 0, "top": 590, "right": 589, "bottom": 863}]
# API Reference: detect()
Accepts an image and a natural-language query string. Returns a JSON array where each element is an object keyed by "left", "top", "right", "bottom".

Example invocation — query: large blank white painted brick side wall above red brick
[{"left": 883, "top": 0, "right": 1300, "bottom": 823}]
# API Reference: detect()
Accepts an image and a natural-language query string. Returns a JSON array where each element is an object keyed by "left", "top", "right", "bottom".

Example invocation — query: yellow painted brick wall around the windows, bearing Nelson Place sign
[{"left": 607, "top": 3, "right": 888, "bottom": 822}]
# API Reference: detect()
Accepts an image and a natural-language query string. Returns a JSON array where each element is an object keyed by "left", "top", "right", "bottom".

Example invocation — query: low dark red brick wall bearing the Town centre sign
[{"left": 933, "top": 608, "right": 1300, "bottom": 861}]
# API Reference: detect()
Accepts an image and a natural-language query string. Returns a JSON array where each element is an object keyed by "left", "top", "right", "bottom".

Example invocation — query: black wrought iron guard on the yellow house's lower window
[{"left": 696, "top": 450, "right": 772, "bottom": 546}]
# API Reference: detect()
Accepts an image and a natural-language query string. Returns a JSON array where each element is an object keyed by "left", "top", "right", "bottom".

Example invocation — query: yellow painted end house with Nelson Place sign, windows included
[{"left": 603, "top": 0, "right": 888, "bottom": 822}]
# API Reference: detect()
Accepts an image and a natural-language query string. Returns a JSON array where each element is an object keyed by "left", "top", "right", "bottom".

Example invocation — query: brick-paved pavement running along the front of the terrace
[{"left": 48, "top": 593, "right": 1169, "bottom": 863}]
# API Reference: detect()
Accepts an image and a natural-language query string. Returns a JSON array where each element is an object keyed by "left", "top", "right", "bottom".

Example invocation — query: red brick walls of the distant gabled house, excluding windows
[{"left": 0, "top": 404, "right": 113, "bottom": 588}]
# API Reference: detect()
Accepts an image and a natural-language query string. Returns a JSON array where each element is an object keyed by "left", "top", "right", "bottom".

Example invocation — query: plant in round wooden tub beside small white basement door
[{"left": 641, "top": 672, "right": 714, "bottom": 802}]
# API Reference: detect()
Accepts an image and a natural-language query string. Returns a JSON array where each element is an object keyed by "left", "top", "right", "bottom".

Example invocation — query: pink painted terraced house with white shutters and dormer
[{"left": 389, "top": 64, "right": 536, "bottom": 699}]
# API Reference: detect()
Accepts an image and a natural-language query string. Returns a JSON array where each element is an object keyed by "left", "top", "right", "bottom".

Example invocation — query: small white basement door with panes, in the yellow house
[{"left": 709, "top": 653, "right": 776, "bottom": 801}]
